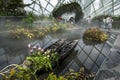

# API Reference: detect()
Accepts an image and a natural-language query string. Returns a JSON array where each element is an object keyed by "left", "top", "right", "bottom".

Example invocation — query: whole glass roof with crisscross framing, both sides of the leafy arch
[{"left": 23, "top": 0, "right": 120, "bottom": 17}]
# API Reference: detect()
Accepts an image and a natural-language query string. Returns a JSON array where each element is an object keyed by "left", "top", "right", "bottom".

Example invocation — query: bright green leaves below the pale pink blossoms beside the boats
[{"left": 26, "top": 50, "right": 58, "bottom": 73}]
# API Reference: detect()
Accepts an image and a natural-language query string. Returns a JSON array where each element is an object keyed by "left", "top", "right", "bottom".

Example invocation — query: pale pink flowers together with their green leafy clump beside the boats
[{"left": 26, "top": 44, "right": 59, "bottom": 73}]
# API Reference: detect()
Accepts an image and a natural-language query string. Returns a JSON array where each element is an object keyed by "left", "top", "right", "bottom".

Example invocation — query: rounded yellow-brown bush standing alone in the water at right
[{"left": 83, "top": 28, "right": 108, "bottom": 43}]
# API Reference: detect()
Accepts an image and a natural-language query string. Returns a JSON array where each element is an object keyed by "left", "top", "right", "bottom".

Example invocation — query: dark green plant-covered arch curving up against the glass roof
[{"left": 52, "top": 2, "right": 83, "bottom": 22}]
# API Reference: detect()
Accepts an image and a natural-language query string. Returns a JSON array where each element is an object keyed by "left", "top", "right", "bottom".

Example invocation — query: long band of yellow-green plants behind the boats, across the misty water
[{"left": 9, "top": 23, "right": 67, "bottom": 39}]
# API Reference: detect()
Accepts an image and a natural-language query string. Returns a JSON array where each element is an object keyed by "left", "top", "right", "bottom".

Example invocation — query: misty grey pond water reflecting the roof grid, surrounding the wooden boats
[{"left": 0, "top": 20, "right": 111, "bottom": 79}]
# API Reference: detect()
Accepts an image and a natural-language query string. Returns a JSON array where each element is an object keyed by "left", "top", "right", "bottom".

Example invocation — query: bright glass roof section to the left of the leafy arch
[{"left": 23, "top": 0, "right": 82, "bottom": 15}]
